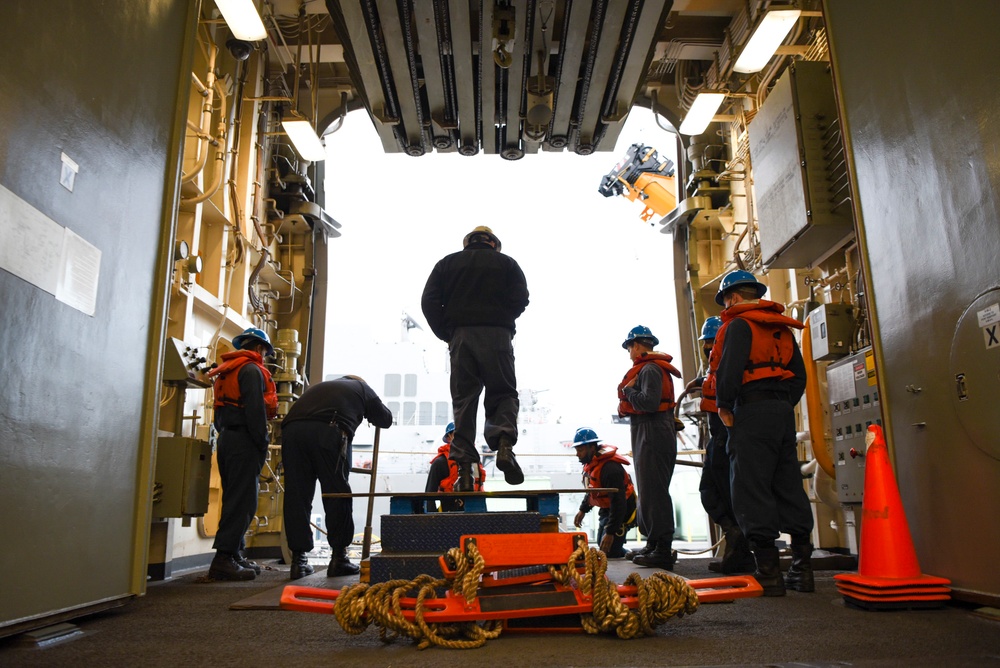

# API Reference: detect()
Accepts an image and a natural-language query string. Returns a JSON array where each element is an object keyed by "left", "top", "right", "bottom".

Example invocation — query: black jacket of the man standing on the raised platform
[{"left": 420, "top": 243, "right": 528, "bottom": 342}]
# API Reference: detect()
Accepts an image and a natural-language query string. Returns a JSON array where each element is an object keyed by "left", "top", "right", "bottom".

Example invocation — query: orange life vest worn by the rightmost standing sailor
[{"left": 708, "top": 299, "right": 803, "bottom": 384}]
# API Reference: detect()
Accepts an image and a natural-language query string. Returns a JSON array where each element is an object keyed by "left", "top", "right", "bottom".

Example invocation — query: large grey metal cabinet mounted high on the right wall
[{"left": 748, "top": 61, "right": 854, "bottom": 268}]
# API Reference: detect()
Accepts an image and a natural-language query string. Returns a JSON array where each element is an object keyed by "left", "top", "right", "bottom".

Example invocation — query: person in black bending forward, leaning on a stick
[{"left": 281, "top": 376, "right": 392, "bottom": 580}]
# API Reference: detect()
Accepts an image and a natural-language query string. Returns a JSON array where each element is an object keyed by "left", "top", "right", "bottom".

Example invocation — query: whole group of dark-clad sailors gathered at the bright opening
[{"left": 201, "top": 226, "right": 813, "bottom": 596}]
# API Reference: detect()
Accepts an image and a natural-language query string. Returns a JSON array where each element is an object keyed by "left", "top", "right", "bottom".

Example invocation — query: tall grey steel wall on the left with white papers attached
[{"left": 0, "top": 0, "right": 196, "bottom": 634}]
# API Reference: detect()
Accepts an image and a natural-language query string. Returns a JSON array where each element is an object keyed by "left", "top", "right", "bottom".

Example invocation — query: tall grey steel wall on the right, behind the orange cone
[{"left": 824, "top": 0, "right": 1000, "bottom": 598}]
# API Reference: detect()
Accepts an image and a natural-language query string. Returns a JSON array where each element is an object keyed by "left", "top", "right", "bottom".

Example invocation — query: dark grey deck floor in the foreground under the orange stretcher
[{"left": 0, "top": 559, "right": 1000, "bottom": 668}]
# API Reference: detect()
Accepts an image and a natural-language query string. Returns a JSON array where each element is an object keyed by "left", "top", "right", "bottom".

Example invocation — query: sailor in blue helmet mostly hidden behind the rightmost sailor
[{"left": 685, "top": 315, "right": 756, "bottom": 575}]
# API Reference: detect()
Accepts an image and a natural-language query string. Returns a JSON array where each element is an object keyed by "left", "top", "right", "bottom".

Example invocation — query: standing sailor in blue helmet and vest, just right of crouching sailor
[{"left": 618, "top": 325, "right": 681, "bottom": 570}]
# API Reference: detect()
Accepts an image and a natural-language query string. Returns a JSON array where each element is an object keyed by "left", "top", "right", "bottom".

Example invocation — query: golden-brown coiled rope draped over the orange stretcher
[{"left": 334, "top": 543, "right": 698, "bottom": 649}]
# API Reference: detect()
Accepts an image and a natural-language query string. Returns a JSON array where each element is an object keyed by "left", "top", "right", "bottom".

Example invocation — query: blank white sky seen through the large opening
[{"left": 324, "top": 107, "right": 694, "bottom": 424}]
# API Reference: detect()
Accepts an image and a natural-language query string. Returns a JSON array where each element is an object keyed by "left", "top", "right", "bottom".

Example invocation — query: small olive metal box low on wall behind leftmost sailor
[{"left": 153, "top": 436, "right": 212, "bottom": 517}]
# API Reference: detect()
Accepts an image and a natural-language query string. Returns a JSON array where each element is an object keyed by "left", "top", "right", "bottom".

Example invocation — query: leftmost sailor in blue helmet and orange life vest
[{"left": 208, "top": 327, "right": 278, "bottom": 580}]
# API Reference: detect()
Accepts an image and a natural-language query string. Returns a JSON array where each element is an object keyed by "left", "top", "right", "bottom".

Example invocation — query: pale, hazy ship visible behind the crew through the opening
[{"left": 310, "top": 313, "right": 710, "bottom": 562}]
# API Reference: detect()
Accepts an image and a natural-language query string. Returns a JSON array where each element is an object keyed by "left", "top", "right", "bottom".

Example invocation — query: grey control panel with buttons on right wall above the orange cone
[{"left": 826, "top": 348, "right": 882, "bottom": 503}]
